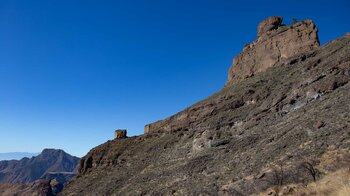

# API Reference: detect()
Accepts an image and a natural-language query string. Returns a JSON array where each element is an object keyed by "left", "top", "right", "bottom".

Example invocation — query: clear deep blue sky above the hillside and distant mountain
[{"left": 0, "top": 0, "right": 350, "bottom": 156}]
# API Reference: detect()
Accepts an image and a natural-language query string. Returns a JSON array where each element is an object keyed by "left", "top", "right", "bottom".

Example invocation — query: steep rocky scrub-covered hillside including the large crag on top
[{"left": 61, "top": 17, "right": 350, "bottom": 195}]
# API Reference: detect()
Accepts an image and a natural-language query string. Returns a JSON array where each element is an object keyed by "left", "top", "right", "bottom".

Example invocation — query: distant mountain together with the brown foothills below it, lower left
[{"left": 0, "top": 149, "right": 79, "bottom": 196}]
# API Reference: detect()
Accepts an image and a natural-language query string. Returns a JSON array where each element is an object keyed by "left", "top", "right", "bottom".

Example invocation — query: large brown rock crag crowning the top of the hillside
[{"left": 226, "top": 16, "right": 320, "bottom": 86}]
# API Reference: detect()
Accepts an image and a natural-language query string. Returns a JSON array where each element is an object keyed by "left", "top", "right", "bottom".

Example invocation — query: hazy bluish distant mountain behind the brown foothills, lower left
[{"left": 0, "top": 149, "right": 79, "bottom": 184}]
